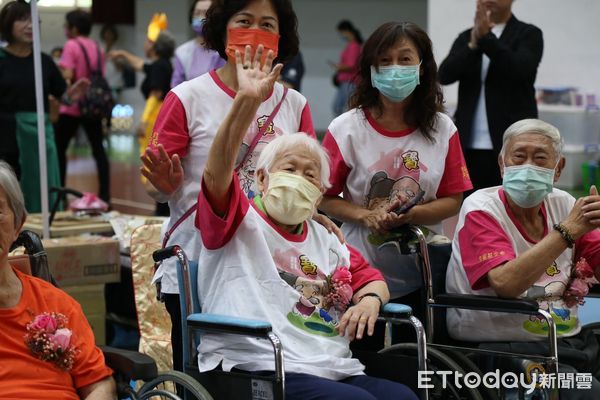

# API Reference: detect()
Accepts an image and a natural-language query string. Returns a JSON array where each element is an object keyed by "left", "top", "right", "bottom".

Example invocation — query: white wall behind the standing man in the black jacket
[{"left": 428, "top": 0, "right": 600, "bottom": 107}]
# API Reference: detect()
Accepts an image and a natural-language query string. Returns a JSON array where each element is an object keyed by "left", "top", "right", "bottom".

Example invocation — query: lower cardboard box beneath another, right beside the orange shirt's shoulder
[{"left": 61, "top": 284, "right": 106, "bottom": 346}]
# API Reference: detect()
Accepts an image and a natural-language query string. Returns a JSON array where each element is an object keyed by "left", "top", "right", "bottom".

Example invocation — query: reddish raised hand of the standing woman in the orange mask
[{"left": 140, "top": 144, "right": 183, "bottom": 195}]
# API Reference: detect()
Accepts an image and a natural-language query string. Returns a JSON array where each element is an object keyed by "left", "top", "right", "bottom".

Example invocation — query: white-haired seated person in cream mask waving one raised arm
[{"left": 186, "top": 45, "right": 416, "bottom": 399}]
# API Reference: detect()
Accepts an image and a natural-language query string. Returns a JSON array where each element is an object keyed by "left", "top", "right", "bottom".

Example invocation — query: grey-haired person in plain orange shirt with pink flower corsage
[{"left": 0, "top": 161, "right": 116, "bottom": 399}]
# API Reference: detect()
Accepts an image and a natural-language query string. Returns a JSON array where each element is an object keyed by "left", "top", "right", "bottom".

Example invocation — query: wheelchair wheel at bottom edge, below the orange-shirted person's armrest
[{"left": 138, "top": 371, "right": 213, "bottom": 400}]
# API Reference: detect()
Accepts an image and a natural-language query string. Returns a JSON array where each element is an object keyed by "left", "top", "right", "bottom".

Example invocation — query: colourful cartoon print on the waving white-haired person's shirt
[{"left": 274, "top": 249, "right": 352, "bottom": 337}]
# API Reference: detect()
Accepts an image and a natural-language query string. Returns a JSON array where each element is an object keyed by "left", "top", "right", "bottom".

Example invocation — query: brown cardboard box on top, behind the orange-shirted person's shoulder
[{"left": 42, "top": 236, "right": 121, "bottom": 287}]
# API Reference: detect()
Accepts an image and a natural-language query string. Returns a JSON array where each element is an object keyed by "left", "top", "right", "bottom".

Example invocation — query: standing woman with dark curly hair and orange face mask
[{"left": 142, "top": 0, "right": 334, "bottom": 376}]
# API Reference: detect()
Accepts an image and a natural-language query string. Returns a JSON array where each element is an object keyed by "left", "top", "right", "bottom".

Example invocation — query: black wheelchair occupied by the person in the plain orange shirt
[{"left": 9, "top": 230, "right": 212, "bottom": 400}]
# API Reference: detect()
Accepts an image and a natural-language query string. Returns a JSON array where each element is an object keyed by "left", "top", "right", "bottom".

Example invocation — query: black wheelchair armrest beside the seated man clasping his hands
[{"left": 430, "top": 293, "right": 540, "bottom": 315}]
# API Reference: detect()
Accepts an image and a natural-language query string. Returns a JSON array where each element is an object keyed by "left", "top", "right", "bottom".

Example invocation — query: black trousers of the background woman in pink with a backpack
[{"left": 55, "top": 114, "right": 110, "bottom": 202}]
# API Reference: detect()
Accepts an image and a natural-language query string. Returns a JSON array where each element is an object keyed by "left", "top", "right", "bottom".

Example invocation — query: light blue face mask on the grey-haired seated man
[{"left": 502, "top": 164, "right": 554, "bottom": 208}]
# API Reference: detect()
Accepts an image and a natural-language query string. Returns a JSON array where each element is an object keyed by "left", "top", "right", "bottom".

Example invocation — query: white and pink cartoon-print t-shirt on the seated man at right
[{"left": 446, "top": 186, "right": 600, "bottom": 342}]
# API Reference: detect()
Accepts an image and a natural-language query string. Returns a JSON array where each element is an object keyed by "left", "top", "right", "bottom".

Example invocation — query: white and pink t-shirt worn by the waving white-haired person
[{"left": 196, "top": 176, "right": 383, "bottom": 380}]
